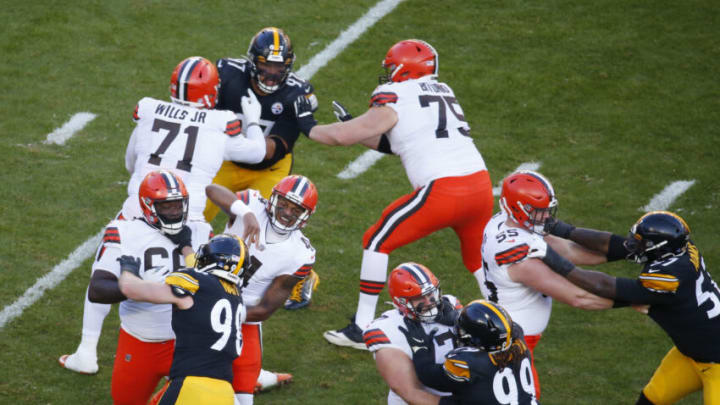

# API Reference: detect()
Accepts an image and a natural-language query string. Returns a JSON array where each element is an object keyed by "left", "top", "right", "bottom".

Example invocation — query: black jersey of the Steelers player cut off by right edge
[{"left": 616, "top": 243, "right": 720, "bottom": 363}]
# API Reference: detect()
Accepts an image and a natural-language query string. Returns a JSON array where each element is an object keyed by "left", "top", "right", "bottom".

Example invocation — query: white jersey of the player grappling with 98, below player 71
[{"left": 92, "top": 219, "right": 212, "bottom": 342}]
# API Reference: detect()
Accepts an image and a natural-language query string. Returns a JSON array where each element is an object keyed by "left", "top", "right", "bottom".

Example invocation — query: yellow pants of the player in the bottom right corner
[{"left": 643, "top": 346, "right": 720, "bottom": 405}]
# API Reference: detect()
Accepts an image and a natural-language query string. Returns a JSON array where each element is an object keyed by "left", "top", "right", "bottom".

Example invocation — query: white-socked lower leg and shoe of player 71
[{"left": 58, "top": 290, "right": 110, "bottom": 374}]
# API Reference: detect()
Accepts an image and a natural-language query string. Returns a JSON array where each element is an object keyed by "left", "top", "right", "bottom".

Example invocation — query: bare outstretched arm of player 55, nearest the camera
[{"left": 508, "top": 258, "right": 613, "bottom": 310}]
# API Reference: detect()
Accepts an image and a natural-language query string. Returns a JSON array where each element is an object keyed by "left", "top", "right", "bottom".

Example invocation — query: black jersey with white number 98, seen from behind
[{"left": 165, "top": 269, "right": 246, "bottom": 383}]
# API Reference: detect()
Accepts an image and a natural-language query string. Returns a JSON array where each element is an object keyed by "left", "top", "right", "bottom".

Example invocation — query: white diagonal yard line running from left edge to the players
[{"left": 0, "top": 231, "right": 103, "bottom": 330}]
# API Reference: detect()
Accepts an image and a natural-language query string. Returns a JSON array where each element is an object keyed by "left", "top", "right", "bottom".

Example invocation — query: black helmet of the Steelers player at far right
[{"left": 625, "top": 211, "right": 690, "bottom": 263}]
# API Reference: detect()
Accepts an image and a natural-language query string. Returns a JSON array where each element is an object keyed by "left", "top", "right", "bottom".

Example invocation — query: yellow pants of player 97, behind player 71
[{"left": 203, "top": 153, "right": 293, "bottom": 222}]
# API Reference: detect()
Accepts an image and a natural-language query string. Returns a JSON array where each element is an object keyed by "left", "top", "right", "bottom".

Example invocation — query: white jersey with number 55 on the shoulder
[{"left": 480, "top": 211, "right": 552, "bottom": 335}]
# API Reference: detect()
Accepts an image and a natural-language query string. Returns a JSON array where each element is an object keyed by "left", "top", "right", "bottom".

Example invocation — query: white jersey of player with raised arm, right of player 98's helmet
[{"left": 225, "top": 190, "right": 315, "bottom": 306}]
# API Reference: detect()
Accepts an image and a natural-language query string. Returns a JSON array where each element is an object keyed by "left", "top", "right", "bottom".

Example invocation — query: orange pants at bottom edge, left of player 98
[{"left": 110, "top": 328, "right": 175, "bottom": 405}]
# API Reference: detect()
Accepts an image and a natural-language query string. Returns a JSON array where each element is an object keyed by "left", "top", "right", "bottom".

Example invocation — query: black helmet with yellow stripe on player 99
[{"left": 455, "top": 300, "right": 513, "bottom": 353}]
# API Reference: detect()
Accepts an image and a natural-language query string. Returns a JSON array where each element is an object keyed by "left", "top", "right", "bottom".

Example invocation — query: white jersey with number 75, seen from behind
[{"left": 370, "top": 76, "right": 486, "bottom": 188}]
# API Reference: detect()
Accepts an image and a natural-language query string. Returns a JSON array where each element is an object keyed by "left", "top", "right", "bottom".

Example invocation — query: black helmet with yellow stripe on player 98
[{"left": 195, "top": 234, "right": 250, "bottom": 285}]
